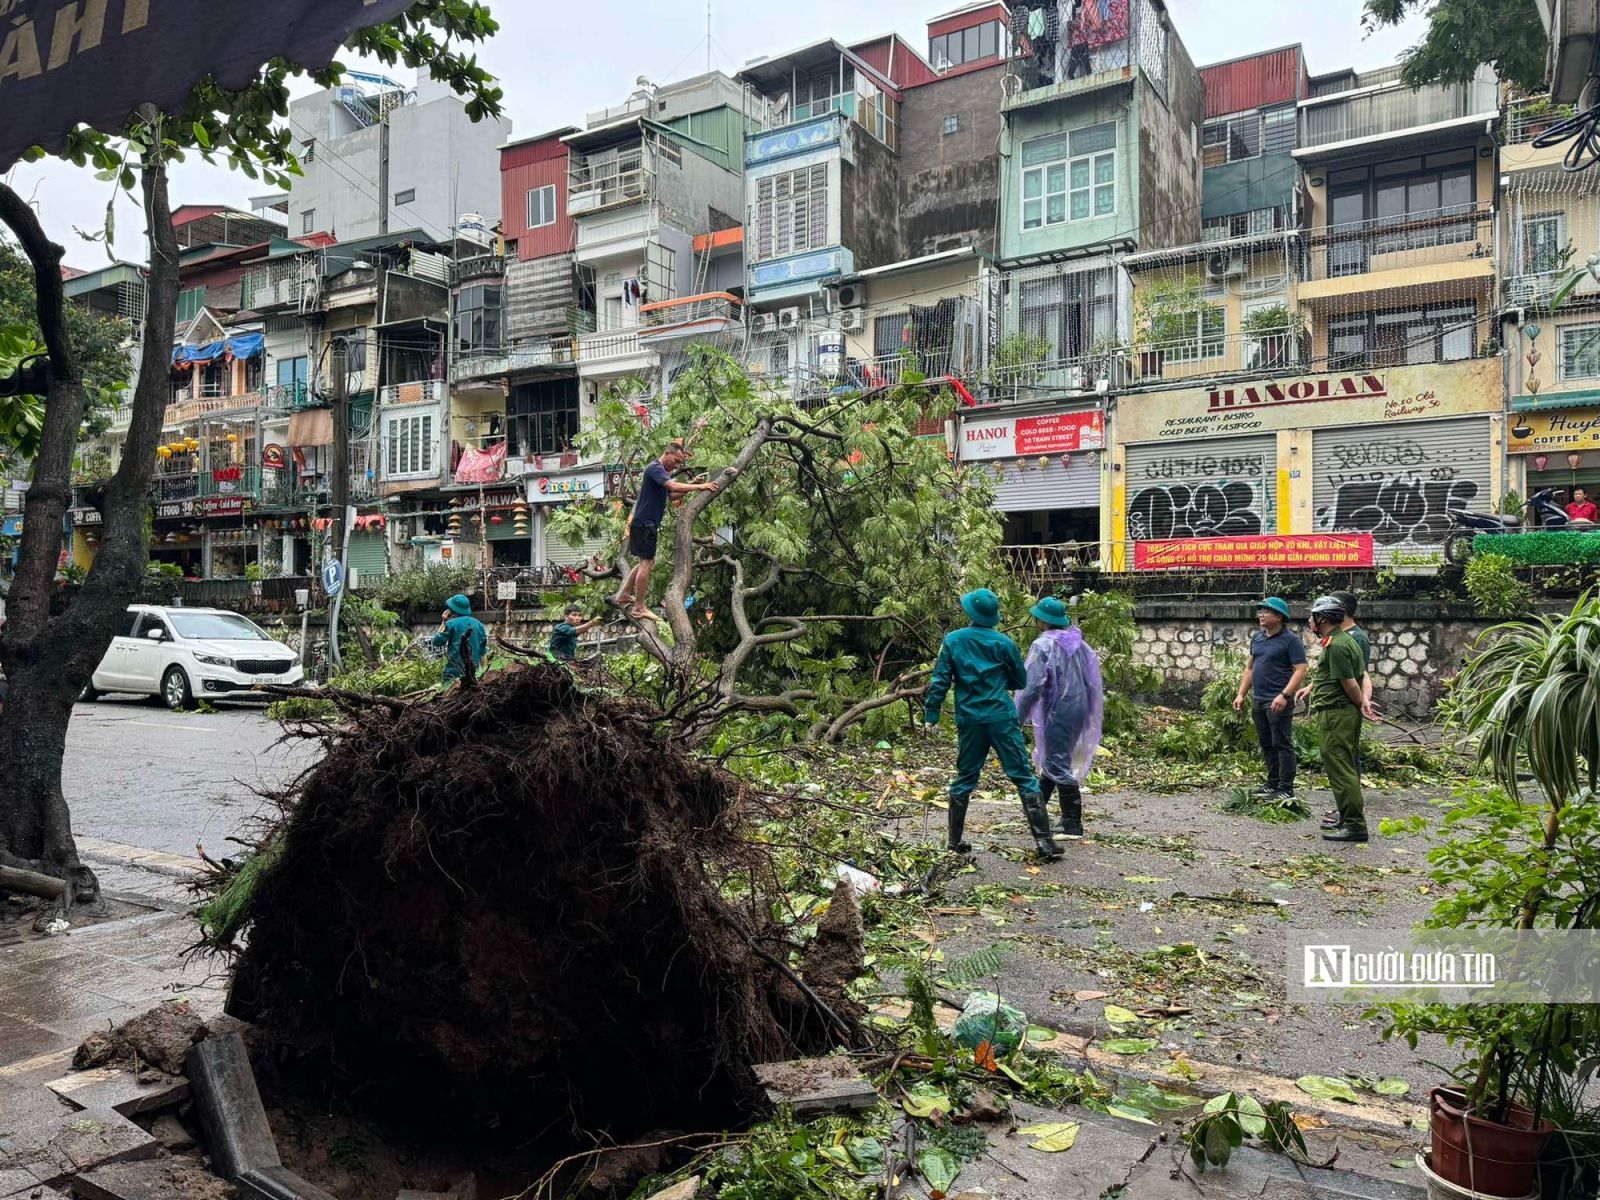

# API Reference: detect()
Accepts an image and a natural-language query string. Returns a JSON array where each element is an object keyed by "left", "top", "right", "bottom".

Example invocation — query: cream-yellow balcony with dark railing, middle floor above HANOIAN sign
[{"left": 1299, "top": 205, "right": 1494, "bottom": 301}]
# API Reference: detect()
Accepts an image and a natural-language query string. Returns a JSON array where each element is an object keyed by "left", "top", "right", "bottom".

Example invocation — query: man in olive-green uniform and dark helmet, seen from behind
[{"left": 1310, "top": 595, "right": 1371, "bottom": 842}]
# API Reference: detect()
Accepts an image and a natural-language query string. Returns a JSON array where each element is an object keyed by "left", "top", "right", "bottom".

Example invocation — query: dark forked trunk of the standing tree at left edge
[{"left": 0, "top": 152, "right": 178, "bottom": 899}]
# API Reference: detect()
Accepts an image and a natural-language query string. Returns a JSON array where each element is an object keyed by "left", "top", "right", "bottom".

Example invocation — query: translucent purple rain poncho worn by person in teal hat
[{"left": 1016, "top": 626, "right": 1106, "bottom": 784}]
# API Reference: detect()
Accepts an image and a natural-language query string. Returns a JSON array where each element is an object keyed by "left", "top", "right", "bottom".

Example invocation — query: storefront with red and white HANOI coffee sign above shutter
[{"left": 957, "top": 406, "right": 1106, "bottom": 546}]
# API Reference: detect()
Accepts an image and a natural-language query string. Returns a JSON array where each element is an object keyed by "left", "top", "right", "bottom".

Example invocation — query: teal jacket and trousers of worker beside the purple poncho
[{"left": 923, "top": 626, "right": 1038, "bottom": 813}]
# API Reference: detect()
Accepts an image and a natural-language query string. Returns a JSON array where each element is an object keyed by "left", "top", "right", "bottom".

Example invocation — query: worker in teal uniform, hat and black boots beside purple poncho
[{"left": 923, "top": 587, "right": 1061, "bottom": 862}]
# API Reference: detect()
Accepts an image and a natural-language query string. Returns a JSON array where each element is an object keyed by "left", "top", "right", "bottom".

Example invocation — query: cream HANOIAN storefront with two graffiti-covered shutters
[{"left": 1104, "top": 358, "right": 1506, "bottom": 570}]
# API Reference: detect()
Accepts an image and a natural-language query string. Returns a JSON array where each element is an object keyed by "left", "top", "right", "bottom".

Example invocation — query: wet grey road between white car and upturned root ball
[{"left": 62, "top": 696, "right": 312, "bottom": 854}]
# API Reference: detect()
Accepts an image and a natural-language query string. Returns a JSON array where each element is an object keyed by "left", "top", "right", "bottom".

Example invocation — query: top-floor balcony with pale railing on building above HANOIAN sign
[{"left": 1294, "top": 67, "right": 1499, "bottom": 158}]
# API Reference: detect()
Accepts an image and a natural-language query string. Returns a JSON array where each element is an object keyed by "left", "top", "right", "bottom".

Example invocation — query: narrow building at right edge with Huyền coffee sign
[{"left": 1499, "top": 94, "right": 1600, "bottom": 502}]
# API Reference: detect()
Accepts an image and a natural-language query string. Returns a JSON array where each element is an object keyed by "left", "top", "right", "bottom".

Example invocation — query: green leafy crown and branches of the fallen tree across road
[{"left": 552, "top": 349, "right": 1010, "bottom": 739}]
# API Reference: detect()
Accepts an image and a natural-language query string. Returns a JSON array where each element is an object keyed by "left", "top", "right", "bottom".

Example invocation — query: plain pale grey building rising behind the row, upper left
[{"left": 288, "top": 70, "right": 510, "bottom": 242}]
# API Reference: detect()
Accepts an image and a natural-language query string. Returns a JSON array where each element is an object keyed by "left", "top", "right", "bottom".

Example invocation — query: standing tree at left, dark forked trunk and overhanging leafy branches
[{"left": 0, "top": 0, "right": 501, "bottom": 899}]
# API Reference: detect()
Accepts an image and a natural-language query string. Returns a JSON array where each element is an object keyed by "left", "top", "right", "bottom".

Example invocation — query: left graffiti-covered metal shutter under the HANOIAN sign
[{"left": 1126, "top": 434, "right": 1278, "bottom": 541}]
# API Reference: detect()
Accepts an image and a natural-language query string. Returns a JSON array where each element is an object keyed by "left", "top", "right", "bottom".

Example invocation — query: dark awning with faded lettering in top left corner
[{"left": 0, "top": 0, "right": 411, "bottom": 171}]
